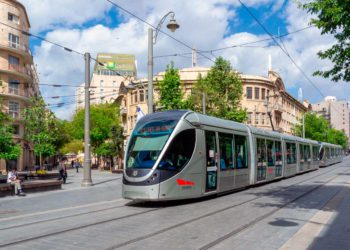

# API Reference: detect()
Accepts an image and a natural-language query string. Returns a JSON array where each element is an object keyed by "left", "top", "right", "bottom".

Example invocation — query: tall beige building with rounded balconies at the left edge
[{"left": 0, "top": 0, "right": 40, "bottom": 171}]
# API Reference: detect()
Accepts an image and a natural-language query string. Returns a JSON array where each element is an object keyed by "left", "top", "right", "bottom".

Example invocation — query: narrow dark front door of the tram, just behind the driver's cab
[{"left": 205, "top": 131, "right": 218, "bottom": 192}]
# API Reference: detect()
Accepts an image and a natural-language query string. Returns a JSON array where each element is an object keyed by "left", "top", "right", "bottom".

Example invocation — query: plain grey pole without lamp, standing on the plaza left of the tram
[{"left": 81, "top": 53, "right": 93, "bottom": 187}]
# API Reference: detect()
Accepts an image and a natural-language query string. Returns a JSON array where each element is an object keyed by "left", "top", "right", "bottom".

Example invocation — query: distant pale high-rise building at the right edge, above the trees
[{"left": 312, "top": 96, "right": 350, "bottom": 144}]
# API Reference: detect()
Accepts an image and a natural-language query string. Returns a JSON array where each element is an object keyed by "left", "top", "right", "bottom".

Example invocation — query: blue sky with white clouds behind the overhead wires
[{"left": 24, "top": 0, "right": 350, "bottom": 118}]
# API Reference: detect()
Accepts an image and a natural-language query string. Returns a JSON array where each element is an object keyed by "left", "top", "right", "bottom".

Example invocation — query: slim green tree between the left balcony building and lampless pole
[{"left": 23, "top": 97, "right": 60, "bottom": 165}]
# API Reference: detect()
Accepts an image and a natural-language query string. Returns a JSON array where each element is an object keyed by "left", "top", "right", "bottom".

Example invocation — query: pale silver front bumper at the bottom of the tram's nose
[{"left": 122, "top": 184, "right": 159, "bottom": 201}]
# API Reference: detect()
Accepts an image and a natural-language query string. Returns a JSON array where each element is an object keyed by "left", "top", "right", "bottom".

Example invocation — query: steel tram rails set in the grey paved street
[{"left": 0, "top": 162, "right": 343, "bottom": 249}]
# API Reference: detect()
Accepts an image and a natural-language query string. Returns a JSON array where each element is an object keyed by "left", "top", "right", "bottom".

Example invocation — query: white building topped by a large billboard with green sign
[{"left": 76, "top": 53, "right": 137, "bottom": 109}]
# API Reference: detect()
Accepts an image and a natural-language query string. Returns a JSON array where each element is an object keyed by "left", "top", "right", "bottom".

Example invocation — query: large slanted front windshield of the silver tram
[{"left": 126, "top": 112, "right": 186, "bottom": 169}]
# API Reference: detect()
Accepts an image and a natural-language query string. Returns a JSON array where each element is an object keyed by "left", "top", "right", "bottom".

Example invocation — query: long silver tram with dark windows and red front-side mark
[{"left": 122, "top": 110, "right": 342, "bottom": 201}]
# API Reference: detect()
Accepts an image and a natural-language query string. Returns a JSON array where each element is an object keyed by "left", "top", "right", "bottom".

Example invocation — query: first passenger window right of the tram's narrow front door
[{"left": 219, "top": 133, "right": 233, "bottom": 170}]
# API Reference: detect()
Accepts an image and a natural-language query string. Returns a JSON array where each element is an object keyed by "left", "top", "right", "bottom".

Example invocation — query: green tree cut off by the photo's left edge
[{"left": 0, "top": 111, "right": 21, "bottom": 160}]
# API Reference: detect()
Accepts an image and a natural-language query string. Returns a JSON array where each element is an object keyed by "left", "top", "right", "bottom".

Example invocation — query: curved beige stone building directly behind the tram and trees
[{"left": 117, "top": 67, "right": 308, "bottom": 141}]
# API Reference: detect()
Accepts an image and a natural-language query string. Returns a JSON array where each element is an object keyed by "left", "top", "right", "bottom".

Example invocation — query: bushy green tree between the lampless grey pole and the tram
[{"left": 67, "top": 103, "right": 124, "bottom": 167}]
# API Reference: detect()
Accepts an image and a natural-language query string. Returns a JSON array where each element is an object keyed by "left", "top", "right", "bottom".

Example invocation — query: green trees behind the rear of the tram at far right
[{"left": 295, "top": 113, "right": 347, "bottom": 148}]
